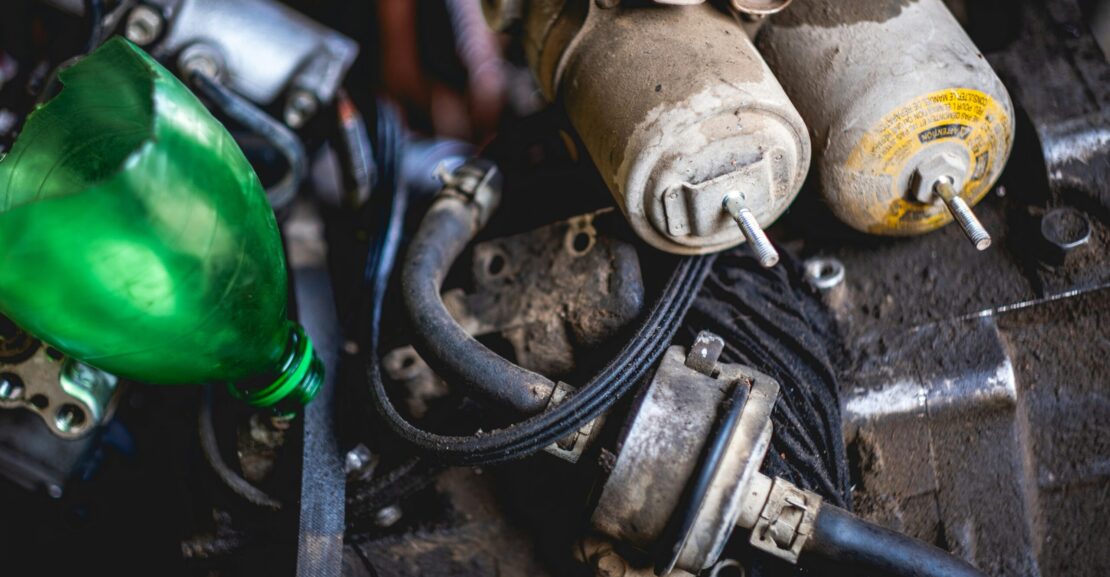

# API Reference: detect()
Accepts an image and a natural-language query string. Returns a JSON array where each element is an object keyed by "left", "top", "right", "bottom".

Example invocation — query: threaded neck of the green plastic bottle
[{"left": 228, "top": 323, "right": 324, "bottom": 415}]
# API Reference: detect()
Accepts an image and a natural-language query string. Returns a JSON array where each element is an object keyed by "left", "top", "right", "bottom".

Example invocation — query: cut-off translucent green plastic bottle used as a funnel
[{"left": 0, "top": 38, "right": 323, "bottom": 412}]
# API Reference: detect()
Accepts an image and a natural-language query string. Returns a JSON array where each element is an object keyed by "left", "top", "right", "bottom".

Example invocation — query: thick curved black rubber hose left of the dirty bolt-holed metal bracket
[{"left": 401, "top": 194, "right": 555, "bottom": 415}]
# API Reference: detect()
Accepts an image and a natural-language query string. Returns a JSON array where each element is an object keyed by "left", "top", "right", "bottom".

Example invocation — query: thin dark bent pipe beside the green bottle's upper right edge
[{"left": 189, "top": 72, "right": 309, "bottom": 211}]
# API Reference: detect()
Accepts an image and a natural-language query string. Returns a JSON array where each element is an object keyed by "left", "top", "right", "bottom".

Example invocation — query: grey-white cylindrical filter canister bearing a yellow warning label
[{"left": 759, "top": 0, "right": 1013, "bottom": 236}]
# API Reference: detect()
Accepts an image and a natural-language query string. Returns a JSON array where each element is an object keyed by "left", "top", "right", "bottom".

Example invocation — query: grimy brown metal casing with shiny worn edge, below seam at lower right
[{"left": 845, "top": 289, "right": 1110, "bottom": 576}]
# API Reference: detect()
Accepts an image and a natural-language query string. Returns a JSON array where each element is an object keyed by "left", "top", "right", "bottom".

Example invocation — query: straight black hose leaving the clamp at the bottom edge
[{"left": 801, "top": 504, "right": 986, "bottom": 577}]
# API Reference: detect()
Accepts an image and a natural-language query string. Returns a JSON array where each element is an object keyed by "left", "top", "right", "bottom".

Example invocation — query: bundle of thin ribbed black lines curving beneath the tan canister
[{"left": 367, "top": 255, "right": 714, "bottom": 465}]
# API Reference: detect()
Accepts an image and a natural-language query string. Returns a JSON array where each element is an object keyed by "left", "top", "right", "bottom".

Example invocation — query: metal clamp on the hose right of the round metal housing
[{"left": 750, "top": 478, "right": 821, "bottom": 563}]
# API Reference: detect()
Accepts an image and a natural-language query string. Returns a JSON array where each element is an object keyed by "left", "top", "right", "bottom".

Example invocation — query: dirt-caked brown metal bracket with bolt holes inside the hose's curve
[{"left": 444, "top": 210, "right": 644, "bottom": 378}]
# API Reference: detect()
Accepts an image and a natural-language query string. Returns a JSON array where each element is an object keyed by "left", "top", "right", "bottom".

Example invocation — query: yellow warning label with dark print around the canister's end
[{"left": 847, "top": 88, "right": 1012, "bottom": 234}]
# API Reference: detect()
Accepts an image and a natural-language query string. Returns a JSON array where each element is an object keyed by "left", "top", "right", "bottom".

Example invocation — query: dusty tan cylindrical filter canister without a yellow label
[{"left": 515, "top": 0, "right": 809, "bottom": 254}]
